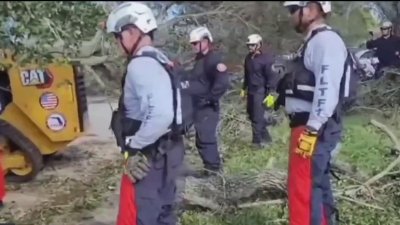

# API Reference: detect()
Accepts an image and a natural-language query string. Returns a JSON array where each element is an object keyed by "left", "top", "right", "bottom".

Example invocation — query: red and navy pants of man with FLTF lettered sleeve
[{"left": 288, "top": 126, "right": 336, "bottom": 225}]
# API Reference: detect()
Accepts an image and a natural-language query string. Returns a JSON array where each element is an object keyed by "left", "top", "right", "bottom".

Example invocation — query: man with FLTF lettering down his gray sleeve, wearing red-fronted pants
[{"left": 276, "top": 1, "right": 356, "bottom": 225}]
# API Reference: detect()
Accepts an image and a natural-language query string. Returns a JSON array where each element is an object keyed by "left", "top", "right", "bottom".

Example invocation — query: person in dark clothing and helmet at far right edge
[{"left": 366, "top": 21, "right": 400, "bottom": 74}]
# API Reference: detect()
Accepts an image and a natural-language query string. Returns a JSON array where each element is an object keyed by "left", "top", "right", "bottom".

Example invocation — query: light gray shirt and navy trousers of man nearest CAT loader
[{"left": 124, "top": 46, "right": 184, "bottom": 225}]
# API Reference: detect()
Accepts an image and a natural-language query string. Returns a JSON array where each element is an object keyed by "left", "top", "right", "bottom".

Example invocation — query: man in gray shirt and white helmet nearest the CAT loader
[{"left": 105, "top": 2, "right": 184, "bottom": 225}]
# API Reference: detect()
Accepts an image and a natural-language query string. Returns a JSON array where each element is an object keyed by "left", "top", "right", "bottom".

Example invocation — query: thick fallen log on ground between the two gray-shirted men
[{"left": 183, "top": 171, "right": 286, "bottom": 211}]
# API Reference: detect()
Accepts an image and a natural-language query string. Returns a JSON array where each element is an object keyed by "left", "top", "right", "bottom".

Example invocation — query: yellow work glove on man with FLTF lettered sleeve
[{"left": 295, "top": 129, "right": 318, "bottom": 158}]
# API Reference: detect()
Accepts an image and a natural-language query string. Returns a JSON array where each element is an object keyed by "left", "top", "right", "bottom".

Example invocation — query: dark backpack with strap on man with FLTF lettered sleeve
[{"left": 301, "top": 26, "right": 360, "bottom": 109}]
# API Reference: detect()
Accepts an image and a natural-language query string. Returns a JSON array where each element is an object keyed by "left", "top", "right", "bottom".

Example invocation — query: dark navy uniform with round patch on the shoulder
[{"left": 182, "top": 51, "right": 229, "bottom": 169}]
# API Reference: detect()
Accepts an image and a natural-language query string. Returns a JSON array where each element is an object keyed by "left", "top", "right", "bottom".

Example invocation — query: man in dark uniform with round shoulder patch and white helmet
[{"left": 182, "top": 26, "right": 229, "bottom": 176}]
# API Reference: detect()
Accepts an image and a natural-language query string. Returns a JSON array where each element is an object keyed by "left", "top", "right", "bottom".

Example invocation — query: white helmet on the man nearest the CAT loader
[{"left": 106, "top": 2, "right": 157, "bottom": 34}]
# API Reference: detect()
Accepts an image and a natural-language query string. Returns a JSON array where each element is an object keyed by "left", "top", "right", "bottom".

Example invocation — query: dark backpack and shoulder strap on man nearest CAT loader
[{"left": 123, "top": 51, "right": 194, "bottom": 138}]
